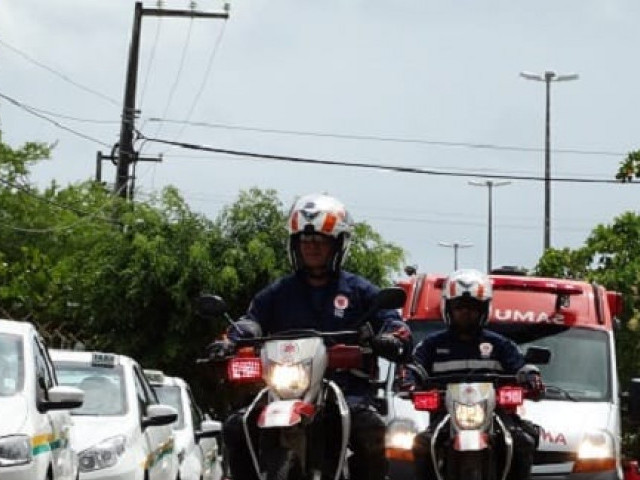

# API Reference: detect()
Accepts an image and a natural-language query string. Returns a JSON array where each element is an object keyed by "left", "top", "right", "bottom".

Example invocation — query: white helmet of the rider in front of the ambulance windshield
[{"left": 440, "top": 269, "right": 493, "bottom": 327}]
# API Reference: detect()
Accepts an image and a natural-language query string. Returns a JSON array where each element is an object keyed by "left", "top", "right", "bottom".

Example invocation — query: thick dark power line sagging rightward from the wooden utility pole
[{"left": 140, "top": 133, "right": 632, "bottom": 184}]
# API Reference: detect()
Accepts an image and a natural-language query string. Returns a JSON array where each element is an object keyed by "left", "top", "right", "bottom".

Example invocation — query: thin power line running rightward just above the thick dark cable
[{"left": 148, "top": 117, "right": 628, "bottom": 157}]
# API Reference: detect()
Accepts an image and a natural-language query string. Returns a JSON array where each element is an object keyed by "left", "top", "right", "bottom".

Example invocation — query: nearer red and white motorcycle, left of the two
[{"left": 204, "top": 288, "right": 405, "bottom": 480}]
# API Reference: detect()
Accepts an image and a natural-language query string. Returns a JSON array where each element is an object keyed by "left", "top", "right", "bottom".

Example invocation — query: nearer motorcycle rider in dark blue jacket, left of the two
[{"left": 212, "top": 194, "right": 412, "bottom": 480}]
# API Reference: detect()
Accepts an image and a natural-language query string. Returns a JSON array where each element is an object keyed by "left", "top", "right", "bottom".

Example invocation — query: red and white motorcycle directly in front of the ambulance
[{"left": 403, "top": 347, "right": 550, "bottom": 480}]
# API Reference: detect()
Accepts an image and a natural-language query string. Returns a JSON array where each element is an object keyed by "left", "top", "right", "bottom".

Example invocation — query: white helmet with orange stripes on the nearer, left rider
[{"left": 287, "top": 194, "right": 353, "bottom": 273}]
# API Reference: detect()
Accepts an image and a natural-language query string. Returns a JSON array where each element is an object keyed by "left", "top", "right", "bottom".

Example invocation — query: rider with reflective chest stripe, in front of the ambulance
[{"left": 413, "top": 269, "right": 544, "bottom": 480}]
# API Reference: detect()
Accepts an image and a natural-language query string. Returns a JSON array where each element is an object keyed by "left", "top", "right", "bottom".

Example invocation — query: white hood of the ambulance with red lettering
[{"left": 519, "top": 400, "right": 615, "bottom": 451}]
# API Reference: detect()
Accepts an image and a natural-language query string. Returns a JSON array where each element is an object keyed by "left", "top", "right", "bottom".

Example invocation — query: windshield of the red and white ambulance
[{"left": 409, "top": 320, "right": 611, "bottom": 402}]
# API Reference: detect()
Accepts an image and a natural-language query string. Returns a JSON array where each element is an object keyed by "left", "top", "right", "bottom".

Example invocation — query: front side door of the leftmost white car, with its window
[{"left": 32, "top": 336, "right": 77, "bottom": 480}]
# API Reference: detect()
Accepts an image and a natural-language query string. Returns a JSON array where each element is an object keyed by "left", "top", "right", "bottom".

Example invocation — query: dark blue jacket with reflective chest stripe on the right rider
[{"left": 413, "top": 329, "right": 525, "bottom": 376}]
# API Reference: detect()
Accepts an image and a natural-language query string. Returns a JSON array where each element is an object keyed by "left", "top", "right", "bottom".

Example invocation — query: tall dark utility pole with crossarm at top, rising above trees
[{"left": 114, "top": 2, "right": 229, "bottom": 199}]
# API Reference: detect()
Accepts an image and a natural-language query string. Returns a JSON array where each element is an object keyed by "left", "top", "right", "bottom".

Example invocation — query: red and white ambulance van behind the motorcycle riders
[{"left": 386, "top": 275, "right": 637, "bottom": 480}]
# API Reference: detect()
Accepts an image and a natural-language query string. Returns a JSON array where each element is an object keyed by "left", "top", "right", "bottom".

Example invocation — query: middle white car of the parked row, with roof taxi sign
[{"left": 51, "top": 350, "right": 179, "bottom": 480}]
